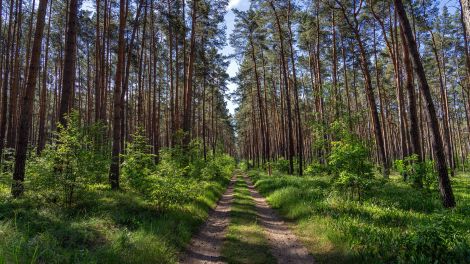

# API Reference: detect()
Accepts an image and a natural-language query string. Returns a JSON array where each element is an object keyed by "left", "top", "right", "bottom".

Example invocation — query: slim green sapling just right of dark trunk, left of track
[{"left": 121, "top": 129, "right": 155, "bottom": 194}]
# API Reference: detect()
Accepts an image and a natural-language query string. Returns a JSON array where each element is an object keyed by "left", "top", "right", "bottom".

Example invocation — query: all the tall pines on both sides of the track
[{"left": 0, "top": 0, "right": 464, "bottom": 207}]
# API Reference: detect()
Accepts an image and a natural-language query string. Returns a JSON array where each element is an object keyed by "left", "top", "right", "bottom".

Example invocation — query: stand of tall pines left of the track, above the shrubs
[{"left": 0, "top": 0, "right": 236, "bottom": 196}]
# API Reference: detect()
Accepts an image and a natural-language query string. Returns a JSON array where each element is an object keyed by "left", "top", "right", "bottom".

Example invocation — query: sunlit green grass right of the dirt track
[{"left": 249, "top": 171, "right": 470, "bottom": 263}]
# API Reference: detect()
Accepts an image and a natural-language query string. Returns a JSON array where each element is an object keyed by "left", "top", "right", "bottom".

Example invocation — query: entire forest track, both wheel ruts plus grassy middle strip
[{"left": 181, "top": 171, "right": 314, "bottom": 264}]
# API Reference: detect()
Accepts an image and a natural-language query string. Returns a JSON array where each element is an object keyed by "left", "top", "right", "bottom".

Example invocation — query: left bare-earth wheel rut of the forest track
[{"left": 180, "top": 173, "right": 237, "bottom": 264}]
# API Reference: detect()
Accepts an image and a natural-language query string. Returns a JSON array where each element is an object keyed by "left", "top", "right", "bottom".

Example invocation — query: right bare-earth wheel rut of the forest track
[{"left": 244, "top": 175, "right": 314, "bottom": 264}]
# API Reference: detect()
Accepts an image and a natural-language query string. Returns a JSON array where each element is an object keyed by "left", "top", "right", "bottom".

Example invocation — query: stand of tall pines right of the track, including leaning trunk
[{"left": 231, "top": 0, "right": 470, "bottom": 207}]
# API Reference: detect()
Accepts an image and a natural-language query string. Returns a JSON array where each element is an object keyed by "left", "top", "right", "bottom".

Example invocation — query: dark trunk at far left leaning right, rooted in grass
[{"left": 11, "top": 0, "right": 47, "bottom": 197}]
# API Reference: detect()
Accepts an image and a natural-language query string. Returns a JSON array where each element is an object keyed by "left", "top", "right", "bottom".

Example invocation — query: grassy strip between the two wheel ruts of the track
[{"left": 222, "top": 178, "right": 276, "bottom": 264}]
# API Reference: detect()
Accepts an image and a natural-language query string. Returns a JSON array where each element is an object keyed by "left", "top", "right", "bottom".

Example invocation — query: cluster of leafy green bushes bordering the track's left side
[{"left": 117, "top": 136, "right": 235, "bottom": 210}]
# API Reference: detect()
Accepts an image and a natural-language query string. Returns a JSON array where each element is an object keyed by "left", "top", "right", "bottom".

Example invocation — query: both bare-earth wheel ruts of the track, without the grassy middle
[{"left": 180, "top": 172, "right": 314, "bottom": 264}]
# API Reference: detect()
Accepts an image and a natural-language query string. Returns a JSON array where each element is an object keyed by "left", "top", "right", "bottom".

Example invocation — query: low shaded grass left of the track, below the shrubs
[{"left": 0, "top": 174, "right": 228, "bottom": 263}]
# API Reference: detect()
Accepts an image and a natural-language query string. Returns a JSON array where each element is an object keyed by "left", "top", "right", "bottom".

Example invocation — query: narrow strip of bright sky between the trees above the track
[{"left": 222, "top": 0, "right": 250, "bottom": 114}]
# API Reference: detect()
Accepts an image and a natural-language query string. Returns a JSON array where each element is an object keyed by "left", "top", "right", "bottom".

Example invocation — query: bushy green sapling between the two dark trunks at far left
[{"left": 27, "top": 112, "right": 108, "bottom": 207}]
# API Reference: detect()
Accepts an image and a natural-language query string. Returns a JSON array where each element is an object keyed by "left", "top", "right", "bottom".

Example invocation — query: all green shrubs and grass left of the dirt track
[{"left": 0, "top": 116, "right": 235, "bottom": 264}]
